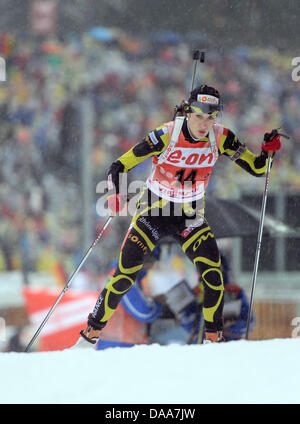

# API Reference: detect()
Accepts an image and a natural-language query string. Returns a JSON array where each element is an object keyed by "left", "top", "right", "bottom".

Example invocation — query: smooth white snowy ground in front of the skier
[{"left": 0, "top": 338, "right": 300, "bottom": 404}]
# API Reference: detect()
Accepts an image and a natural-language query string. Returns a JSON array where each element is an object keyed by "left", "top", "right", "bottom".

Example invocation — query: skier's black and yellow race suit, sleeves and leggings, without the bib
[{"left": 89, "top": 120, "right": 267, "bottom": 331}]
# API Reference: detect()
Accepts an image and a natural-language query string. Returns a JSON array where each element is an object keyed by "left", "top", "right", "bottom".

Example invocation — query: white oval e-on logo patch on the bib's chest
[{"left": 167, "top": 149, "right": 215, "bottom": 168}]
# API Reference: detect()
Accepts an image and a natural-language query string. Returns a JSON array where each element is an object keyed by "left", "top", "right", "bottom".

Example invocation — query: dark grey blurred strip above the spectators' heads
[{"left": 0, "top": 0, "right": 300, "bottom": 49}]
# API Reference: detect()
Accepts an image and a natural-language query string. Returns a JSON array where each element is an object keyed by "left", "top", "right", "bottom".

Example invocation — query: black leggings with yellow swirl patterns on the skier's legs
[{"left": 90, "top": 189, "right": 224, "bottom": 331}]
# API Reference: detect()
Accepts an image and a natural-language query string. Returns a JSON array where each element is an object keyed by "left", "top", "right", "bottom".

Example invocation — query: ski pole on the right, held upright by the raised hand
[{"left": 245, "top": 128, "right": 289, "bottom": 340}]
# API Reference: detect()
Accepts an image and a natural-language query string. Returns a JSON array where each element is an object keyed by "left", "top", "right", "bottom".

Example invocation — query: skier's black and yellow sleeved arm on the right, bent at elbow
[{"left": 219, "top": 128, "right": 268, "bottom": 177}]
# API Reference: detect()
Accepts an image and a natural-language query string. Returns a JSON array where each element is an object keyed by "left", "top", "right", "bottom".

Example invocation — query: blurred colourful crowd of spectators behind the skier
[{"left": 0, "top": 33, "right": 300, "bottom": 282}]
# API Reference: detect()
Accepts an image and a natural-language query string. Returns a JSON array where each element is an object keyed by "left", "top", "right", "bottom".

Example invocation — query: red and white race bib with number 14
[{"left": 146, "top": 121, "right": 223, "bottom": 203}]
